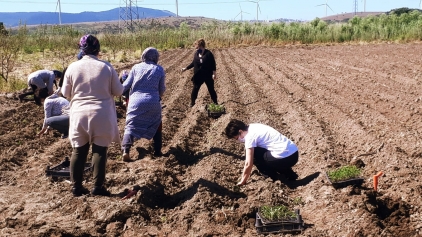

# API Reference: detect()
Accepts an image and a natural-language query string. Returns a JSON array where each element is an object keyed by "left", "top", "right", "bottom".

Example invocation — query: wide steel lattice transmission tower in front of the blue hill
[{"left": 119, "top": 0, "right": 139, "bottom": 32}]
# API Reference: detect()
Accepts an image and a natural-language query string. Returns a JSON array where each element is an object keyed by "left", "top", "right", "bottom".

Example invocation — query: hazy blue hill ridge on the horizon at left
[{"left": 0, "top": 7, "right": 176, "bottom": 28}]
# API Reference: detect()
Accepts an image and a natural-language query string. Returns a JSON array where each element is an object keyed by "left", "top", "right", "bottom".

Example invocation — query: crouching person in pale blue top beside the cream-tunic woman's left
[{"left": 35, "top": 89, "right": 69, "bottom": 139}]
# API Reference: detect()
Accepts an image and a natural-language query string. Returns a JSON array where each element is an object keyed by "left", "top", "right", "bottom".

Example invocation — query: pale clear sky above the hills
[{"left": 0, "top": 0, "right": 421, "bottom": 21}]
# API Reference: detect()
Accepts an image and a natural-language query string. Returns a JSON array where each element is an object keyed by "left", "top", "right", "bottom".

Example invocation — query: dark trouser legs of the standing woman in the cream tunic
[{"left": 70, "top": 143, "right": 107, "bottom": 187}]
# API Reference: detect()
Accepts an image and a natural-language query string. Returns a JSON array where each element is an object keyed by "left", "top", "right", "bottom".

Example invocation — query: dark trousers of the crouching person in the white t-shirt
[{"left": 254, "top": 147, "right": 299, "bottom": 174}]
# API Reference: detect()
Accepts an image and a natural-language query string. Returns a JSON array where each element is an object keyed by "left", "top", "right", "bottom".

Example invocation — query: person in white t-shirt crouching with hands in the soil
[{"left": 225, "top": 119, "right": 299, "bottom": 185}]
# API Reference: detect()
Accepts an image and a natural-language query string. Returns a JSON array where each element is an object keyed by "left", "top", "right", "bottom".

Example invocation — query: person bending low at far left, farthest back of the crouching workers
[{"left": 18, "top": 70, "right": 63, "bottom": 105}]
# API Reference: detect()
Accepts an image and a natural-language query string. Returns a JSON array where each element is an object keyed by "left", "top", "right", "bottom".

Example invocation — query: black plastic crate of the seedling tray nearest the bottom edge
[{"left": 255, "top": 209, "right": 304, "bottom": 234}]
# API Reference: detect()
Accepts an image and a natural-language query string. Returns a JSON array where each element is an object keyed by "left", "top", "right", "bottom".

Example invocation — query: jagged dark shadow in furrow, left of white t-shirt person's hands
[{"left": 138, "top": 178, "right": 246, "bottom": 209}]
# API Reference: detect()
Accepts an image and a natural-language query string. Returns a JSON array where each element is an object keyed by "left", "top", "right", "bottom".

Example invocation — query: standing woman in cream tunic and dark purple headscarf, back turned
[{"left": 62, "top": 35, "right": 123, "bottom": 196}]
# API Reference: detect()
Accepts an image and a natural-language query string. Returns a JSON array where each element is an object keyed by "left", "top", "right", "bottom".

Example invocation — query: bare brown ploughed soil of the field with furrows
[{"left": 0, "top": 43, "right": 422, "bottom": 236}]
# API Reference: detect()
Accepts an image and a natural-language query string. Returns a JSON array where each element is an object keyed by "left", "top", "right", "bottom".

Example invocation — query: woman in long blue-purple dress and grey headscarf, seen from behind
[{"left": 122, "top": 47, "right": 166, "bottom": 161}]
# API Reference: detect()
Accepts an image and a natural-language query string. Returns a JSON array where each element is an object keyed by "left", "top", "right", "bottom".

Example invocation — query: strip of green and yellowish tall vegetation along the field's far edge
[{"left": 0, "top": 11, "right": 422, "bottom": 85}]
